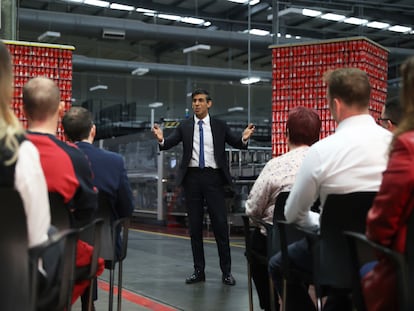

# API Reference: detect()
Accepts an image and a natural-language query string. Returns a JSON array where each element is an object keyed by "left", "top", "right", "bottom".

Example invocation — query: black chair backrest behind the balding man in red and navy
[{"left": 49, "top": 192, "right": 72, "bottom": 230}]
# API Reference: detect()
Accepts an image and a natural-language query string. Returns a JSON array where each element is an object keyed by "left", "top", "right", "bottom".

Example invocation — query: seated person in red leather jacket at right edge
[{"left": 363, "top": 57, "right": 414, "bottom": 311}]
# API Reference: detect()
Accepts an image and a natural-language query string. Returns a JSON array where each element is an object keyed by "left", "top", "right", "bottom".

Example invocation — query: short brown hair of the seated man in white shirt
[{"left": 324, "top": 68, "right": 371, "bottom": 108}]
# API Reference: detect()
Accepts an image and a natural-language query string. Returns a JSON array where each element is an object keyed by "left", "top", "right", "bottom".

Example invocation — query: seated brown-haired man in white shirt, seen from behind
[{"left": 269, "top": 68, "right": 392, "bottom": 311}]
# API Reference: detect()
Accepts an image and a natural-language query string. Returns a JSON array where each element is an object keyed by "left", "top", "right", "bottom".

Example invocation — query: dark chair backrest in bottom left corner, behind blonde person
[{"left": 0, "top": 188, "right": 32, "bottom": 311}]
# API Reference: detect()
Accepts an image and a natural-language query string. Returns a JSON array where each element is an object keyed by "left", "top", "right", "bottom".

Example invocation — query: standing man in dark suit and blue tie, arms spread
[{"left": 152, "top": 89, "right": 254, "bottom": 285}]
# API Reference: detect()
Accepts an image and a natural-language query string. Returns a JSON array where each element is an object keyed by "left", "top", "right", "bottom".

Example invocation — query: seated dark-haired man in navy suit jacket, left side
[{"left": 62, "top": 107, "right": 134, "bottom": 304}]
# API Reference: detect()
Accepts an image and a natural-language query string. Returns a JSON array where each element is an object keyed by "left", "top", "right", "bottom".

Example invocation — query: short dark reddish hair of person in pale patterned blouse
[{"left": 286, "top": 106, "right": 322, "bottom": 146}]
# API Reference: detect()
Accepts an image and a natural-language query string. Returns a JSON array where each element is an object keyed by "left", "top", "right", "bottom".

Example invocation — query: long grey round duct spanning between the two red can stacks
[{"left": 72, "top": 55, "right": 272, "bottom": 81}]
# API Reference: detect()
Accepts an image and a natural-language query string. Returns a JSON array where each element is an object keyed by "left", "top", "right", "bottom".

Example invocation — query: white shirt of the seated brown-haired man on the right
[{"left": 285, "top": 114, "right": 392, "bottom": 229}]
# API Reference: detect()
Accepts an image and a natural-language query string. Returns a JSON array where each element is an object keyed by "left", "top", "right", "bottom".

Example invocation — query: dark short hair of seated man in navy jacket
[{"left": 62, "top": 107, "right": 93, "bottom": 142}]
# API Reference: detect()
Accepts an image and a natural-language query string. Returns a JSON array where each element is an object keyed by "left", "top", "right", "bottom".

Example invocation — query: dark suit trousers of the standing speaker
[{"left": 183, "top": 168, "right": 231, "bottom": 274}]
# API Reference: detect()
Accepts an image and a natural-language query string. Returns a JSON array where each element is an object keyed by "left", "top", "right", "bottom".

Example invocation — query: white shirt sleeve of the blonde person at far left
[{"left": 14, "top": 140, "right": 50, "bottom": 247}]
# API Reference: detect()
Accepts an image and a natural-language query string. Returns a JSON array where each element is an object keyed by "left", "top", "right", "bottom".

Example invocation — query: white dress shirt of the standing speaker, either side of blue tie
[{"left": 189, "top": 115, "right": 217, "bottom": 168}]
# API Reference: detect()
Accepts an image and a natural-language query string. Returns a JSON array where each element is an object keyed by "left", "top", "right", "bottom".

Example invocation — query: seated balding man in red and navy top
[{"left": 23, "top": 77, "right": 104, "bottom": 310}]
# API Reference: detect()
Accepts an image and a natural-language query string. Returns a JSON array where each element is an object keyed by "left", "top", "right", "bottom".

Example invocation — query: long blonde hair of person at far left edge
[{"left": 0, "top": 41, "right": 24, "bottom": 165}]
